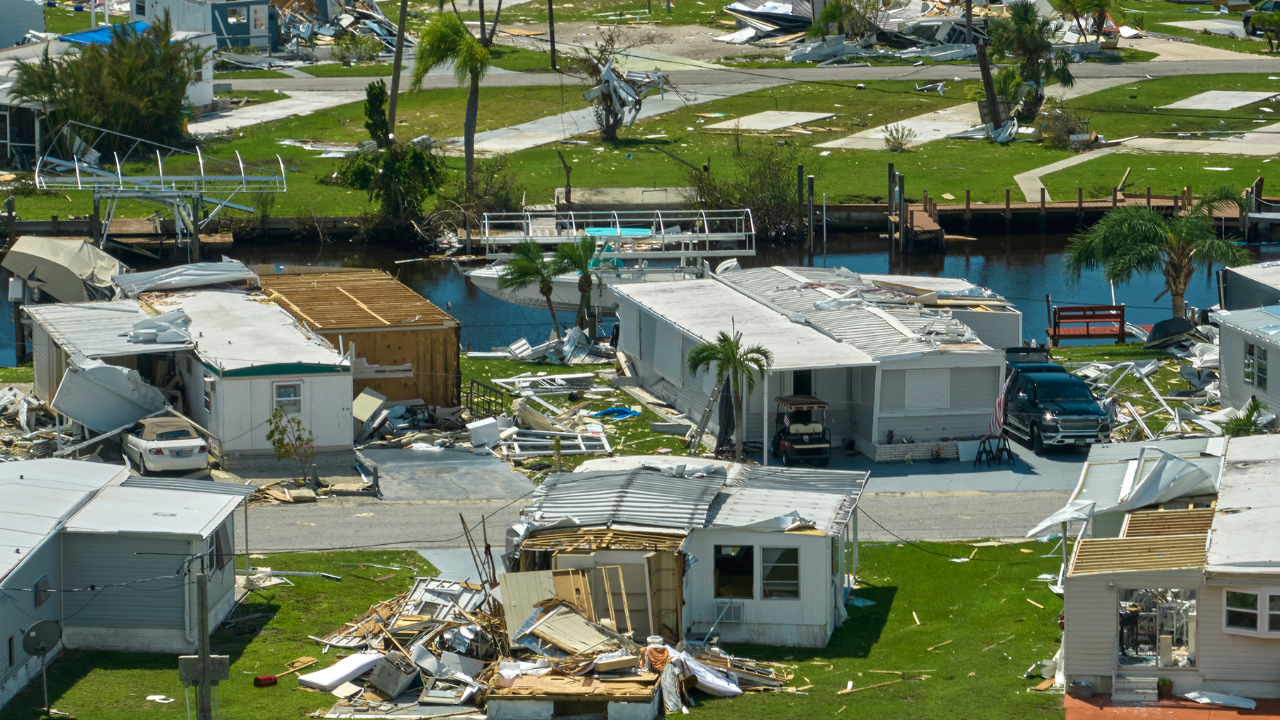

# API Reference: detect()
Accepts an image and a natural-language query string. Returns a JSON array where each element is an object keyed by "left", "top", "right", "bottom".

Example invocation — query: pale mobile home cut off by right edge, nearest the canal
[{"left": 1215, "top": 305, "right": 1280, "bottom": 409}]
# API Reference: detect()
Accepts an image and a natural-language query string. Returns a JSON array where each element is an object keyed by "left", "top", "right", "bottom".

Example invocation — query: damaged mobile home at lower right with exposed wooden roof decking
[{"left": 1062, "top": 436, "right": 1280, "bottom": 701}]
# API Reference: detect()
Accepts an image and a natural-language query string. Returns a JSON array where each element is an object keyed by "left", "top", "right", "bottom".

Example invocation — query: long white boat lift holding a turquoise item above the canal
[{"left": 479, "top": 209, "right": 755, "bottom": 264}]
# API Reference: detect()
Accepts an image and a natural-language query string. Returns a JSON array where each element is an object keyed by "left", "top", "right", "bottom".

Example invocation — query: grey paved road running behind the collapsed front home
[{"left": 236, "top": 484, "right": 1068, "bottom": 552}]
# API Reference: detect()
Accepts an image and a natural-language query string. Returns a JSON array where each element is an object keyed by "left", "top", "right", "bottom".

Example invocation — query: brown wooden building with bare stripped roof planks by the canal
[{"left": 259, "top": 265, "right": 462, "bottom": 407}]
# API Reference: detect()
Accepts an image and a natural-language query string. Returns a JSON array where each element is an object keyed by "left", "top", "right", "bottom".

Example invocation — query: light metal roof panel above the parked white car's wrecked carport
[{"left": 23, "top": 300, "right": 195, "bottom": 359}]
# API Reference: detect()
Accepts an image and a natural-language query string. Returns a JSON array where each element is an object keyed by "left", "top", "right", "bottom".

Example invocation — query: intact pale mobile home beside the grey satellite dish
[{"left": 0, "top": 460, "right": 252, "bottom": 707}]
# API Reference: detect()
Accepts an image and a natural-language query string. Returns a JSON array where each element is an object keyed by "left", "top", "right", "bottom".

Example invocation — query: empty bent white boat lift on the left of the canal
[{"left": 35, "top": 122, "right": 288, "bottom": 255}]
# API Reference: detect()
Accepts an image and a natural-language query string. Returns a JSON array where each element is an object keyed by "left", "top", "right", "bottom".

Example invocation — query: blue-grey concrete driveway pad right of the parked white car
[{"left": 362, "top": 448, "right": 534, "bottom": 502}]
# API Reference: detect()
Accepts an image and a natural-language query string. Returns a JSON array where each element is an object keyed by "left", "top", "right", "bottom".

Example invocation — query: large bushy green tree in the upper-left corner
[{"left": 9, "top": 10, "right": 207, "bottom": 152}]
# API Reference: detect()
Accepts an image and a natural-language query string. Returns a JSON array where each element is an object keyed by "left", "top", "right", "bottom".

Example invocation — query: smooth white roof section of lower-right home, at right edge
[{"left": 1206, "top": 436, "right": 1280, "bottom": 571}]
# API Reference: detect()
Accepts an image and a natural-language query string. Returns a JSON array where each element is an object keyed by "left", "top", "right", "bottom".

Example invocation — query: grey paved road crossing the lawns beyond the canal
[{"left": 233, "top": 56, "right": 1280, "bottom": 91}]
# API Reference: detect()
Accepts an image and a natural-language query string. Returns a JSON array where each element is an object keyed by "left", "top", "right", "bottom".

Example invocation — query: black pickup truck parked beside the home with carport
[{"left": 1005, "top": 363, "right": 1111, "bottom": 454}]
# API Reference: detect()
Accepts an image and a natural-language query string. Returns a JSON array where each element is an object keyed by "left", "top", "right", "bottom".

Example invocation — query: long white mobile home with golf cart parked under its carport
[{"left": 611, "top": 268, "right": 1020, "bottom": 464}]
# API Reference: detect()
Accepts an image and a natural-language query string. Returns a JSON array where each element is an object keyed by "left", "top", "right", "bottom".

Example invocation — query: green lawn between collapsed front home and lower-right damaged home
[{"left": 691, "top": 542, "right": 1064, "bottom": 720}]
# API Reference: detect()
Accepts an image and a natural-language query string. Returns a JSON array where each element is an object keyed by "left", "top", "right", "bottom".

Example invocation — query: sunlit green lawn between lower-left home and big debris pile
[{"left": 5, "top": 551, "right": 435, "bottom": 720}]
